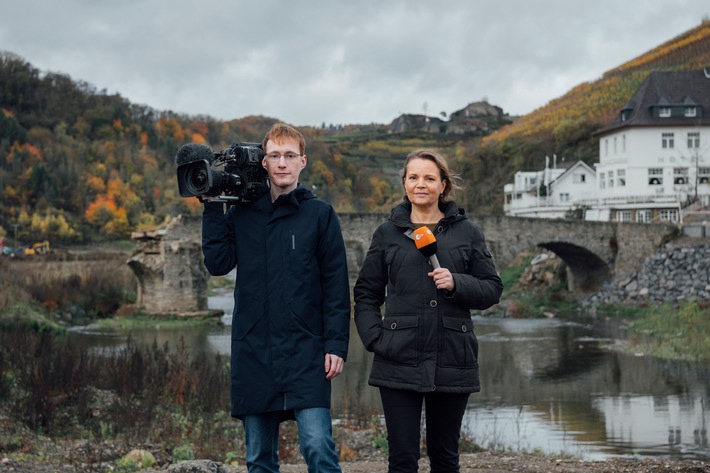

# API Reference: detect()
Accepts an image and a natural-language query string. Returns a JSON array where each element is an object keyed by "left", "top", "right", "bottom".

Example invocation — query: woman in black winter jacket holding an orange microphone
[{"left": 354, "top": 150, "right": 503, "bottom": 473}]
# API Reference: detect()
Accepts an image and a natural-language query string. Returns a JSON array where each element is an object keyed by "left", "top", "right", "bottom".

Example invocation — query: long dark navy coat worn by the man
[{"left": 202, "top": 185, "right": 350, "bottom": 418}]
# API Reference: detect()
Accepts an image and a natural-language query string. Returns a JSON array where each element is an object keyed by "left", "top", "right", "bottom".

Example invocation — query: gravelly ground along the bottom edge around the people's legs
[{"left": 0, "top": 408, "right": 710, "bottom": 473}]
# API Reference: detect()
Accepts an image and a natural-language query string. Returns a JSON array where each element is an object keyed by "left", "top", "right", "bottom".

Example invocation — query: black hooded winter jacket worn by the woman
[{"left": 354, "top": 202, "right": 503, "bottom": 393}]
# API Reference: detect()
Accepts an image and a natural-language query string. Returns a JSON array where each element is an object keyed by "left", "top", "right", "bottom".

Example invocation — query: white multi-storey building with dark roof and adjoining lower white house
[{"left": 505, "top": 70, "right": 710, "bottom": 222}]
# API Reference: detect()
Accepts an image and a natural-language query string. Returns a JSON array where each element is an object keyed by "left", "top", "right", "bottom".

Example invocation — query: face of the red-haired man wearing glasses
[{"left": 262, "top": 140, "right": 306, "bottom": 195}]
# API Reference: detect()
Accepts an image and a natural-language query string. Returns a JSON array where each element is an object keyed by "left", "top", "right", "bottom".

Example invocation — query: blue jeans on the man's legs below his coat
[{"left": 244, "top": 407, "right": 341, "bottom": 473}]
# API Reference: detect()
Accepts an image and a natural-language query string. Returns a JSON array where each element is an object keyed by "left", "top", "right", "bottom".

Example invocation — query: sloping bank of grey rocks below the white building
[{"left": 583, "top": 240, "right": 710, "bottom": 306}]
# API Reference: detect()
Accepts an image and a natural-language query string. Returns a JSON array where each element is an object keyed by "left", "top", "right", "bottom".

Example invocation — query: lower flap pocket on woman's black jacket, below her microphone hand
[{"left": 438, "top": 315, "right": 478, "bottom": 368}]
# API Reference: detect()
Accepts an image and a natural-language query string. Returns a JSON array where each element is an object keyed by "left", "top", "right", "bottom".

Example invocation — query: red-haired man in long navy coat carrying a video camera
[{"left": 202, "top": 123, "right": 350, "bottom": 473}]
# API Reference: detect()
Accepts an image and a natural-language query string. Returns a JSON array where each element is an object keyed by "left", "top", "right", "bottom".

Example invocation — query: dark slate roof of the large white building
[{"left": 596, "top": 68, "right": 710, "bottom": 135}]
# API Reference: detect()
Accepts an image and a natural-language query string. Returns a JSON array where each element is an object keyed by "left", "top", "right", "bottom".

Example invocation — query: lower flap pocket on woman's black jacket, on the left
[{"left": 372, "top": 315, "right": 419, "bottom": 366}]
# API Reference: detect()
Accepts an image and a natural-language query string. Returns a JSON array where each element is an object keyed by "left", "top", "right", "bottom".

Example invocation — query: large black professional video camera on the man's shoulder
[{"left": 175, "top": 143, "right": 268, "bottom": 204}]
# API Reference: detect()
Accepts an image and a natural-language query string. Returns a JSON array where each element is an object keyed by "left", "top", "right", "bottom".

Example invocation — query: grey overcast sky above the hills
[{"left": 0, "top": 0, "right": 710, "bottom": 126}]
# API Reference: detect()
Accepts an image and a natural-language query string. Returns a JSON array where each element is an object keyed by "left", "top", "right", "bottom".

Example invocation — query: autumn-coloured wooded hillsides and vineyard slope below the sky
[{"left": 0, "top": 20, "right": 710, "bottom": 244}]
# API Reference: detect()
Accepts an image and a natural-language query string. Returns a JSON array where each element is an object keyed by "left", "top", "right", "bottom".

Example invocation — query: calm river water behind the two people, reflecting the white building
[{"left": 75, "top": 284, "right": 710, "bottom": 459}]
